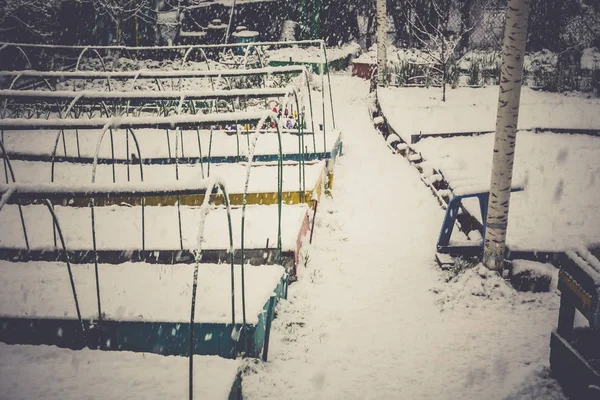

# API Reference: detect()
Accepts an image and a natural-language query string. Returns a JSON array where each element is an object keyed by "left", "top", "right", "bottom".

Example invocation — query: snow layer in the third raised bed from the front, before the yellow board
[{"left": 0, "top": 204, "right": 309, "bottom": 251}]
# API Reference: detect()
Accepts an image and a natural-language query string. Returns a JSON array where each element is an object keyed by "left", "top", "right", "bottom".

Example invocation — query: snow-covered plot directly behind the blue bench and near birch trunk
[{"left": 413, "top": 131, "right": 600, "bottom": 251}]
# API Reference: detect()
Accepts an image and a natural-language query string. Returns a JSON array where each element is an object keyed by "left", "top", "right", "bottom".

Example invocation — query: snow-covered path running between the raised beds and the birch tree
[{"left": 243, "top": 75, "right": 561, "bottom": 399}]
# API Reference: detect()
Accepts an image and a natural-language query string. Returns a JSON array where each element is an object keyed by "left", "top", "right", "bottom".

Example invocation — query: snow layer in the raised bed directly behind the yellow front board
[{"left": 11, "top": 161, "right": 325, "bottom": 194}]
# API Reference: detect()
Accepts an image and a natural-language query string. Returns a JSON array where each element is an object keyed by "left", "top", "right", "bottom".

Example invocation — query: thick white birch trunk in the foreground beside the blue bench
[{"left": 483, "top": 0, "right": 531, "bottom": 270}]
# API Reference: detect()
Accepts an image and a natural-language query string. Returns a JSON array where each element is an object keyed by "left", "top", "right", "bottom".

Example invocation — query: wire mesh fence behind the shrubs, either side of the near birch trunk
[{"left": 388, "top": 0, "right": 600, "bottom": 52}]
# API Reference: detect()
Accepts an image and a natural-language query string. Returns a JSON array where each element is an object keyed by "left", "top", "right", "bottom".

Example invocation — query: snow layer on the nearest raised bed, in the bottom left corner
[{"left": 0, "top": 343, "right": 240, "bottom": 400}]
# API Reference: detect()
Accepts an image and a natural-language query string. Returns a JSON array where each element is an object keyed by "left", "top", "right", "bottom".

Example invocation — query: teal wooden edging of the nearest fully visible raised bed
[{"left": 0, "top": 276, "right": 288, "bottom": 358}]
